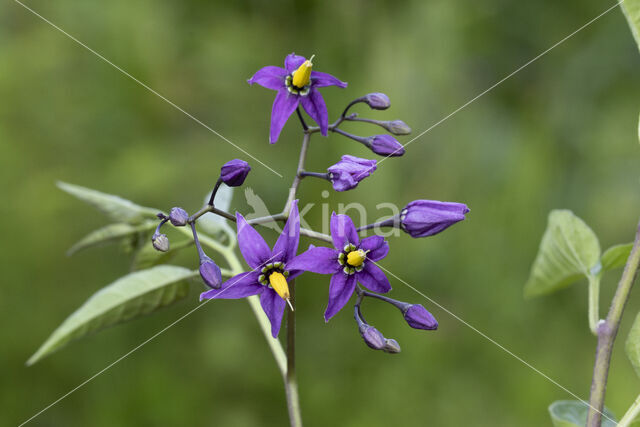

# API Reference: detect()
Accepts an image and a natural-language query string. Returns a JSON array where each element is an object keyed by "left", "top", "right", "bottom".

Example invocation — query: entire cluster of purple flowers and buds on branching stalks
[{"left": 153, "top": 53, "right": 469, "bottom": 353}]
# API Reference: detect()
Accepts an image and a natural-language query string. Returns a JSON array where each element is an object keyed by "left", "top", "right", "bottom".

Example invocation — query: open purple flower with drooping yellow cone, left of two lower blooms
[{"left": 200, "top": 200, "right": 304, "bottom": 338}]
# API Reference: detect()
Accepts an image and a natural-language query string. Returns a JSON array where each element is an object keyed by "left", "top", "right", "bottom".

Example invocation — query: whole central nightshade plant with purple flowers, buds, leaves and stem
[{"left": 35, "top": 54, "right": 468, "bottom": 427}]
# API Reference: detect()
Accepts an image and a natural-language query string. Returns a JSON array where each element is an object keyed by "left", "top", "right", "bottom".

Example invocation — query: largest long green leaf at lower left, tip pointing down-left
[{"left": 27, "top": 265, "right": 198, "bottom": 365}]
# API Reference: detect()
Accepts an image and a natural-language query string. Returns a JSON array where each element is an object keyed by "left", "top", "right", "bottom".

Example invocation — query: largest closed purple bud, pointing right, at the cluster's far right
[{"left": 400, "top": 200, "right": 469, "bottom": 237}]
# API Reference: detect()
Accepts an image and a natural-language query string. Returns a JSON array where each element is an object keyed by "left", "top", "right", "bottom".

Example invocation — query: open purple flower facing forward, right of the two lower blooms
[{"left": 289, "top": 213, "right": 391, "bottom": 322}]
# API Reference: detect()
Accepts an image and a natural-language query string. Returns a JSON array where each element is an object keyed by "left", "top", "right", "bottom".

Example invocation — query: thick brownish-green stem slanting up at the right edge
[{"left": 587, "top": 224, "right": 640, "bottom": 427}]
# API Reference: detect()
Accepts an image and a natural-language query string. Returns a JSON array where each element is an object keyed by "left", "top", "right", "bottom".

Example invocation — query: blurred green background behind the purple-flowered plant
[{"left": 0, "top": 0, "right": 640, "bottom": 427}]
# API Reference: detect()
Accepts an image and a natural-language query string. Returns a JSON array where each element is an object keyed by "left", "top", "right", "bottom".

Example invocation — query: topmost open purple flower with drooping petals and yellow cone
[{"left": 247, "top": 53, "right": 347, "bottom": 144}]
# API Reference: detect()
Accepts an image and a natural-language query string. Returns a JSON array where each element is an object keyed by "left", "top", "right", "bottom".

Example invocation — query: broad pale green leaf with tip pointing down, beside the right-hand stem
[{"left": 524, "top": 210, "right": 600, "bottom": 297}]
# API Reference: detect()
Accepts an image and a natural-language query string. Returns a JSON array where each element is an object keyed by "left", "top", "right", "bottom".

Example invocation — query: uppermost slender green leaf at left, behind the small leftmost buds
[{"left": 58, "top": 182, "right": 159, "bottom": 224}]
